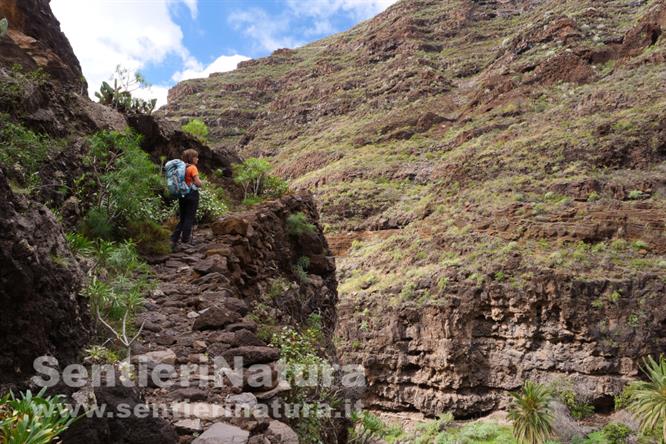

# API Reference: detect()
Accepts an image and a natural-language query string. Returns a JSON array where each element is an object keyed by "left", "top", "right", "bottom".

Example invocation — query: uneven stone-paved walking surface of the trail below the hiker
[{"left": 135, "top": 229, "right": 298, "bottom": 444}]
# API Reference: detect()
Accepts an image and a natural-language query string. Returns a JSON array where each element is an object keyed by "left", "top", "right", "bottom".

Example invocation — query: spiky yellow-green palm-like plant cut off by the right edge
[{"left": 628, "top": 355, "right": 666, "bottom": 443}]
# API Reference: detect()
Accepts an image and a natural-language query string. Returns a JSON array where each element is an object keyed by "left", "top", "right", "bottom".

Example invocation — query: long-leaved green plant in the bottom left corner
[{"left": 0, "top": 387, "right": 76, "bottom": 444}]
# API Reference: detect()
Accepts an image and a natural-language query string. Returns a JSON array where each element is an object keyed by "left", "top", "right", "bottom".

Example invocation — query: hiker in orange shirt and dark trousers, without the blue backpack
[{"left": 171, "top": 149, "right": 201, "bottom": 250}]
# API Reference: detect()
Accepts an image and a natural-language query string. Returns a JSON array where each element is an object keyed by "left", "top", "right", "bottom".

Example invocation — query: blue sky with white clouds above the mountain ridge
[{"left": 51, "top": 0, "right": 396, "bottom": 107}]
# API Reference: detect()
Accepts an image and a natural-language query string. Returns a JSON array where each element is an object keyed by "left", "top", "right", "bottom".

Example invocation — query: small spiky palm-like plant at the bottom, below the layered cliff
[{"left": 509, "top": 381, "right": 554, "bottom": 444}]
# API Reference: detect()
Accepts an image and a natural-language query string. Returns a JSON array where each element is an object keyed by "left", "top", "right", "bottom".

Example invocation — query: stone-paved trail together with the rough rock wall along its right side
[{"left": 66, "top": 194, "right": 337, "bottom": 444}]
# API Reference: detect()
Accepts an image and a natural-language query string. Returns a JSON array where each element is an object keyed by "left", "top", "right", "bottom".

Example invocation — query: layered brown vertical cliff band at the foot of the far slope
[{"left": 339, "top": 274, "right": 666, "bottom": 417}]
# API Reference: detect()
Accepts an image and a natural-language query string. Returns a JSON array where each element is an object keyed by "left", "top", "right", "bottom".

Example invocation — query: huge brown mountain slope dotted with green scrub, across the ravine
[{"left": 164, "top": 0, "right": 666, "bottom": 415}]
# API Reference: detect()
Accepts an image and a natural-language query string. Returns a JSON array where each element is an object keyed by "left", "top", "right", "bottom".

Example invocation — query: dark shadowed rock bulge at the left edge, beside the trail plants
[{"left": 0, "top": 169, "right": 90, "bottom": 384}]
